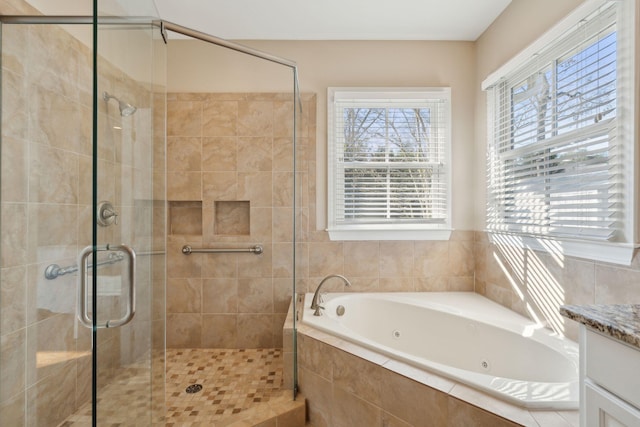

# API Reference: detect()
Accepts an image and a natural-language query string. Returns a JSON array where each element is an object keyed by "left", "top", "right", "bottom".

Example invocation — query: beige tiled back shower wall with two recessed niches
[{"left": 167, "top": 93, "right": 315, "bottom": 348}]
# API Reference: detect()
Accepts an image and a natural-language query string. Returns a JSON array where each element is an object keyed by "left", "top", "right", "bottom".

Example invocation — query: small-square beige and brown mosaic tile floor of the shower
[{"left": 60, "top": 349, "right": 291, "bottom": 427}]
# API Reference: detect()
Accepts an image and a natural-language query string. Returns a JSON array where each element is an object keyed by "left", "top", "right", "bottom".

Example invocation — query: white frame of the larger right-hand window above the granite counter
[{"left": 482, "top": 0, "right": 639, "bottom": 265}]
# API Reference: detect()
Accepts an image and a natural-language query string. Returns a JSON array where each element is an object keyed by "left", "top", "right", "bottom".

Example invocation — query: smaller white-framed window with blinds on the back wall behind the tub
[{"left": 328, "top": 88, "right": 451, "bottom": 240}]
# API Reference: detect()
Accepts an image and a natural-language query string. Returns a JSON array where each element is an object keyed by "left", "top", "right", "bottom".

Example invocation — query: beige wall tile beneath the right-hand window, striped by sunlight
[{"left": 474, "top": 231, "right": 640, "bottom": 341}]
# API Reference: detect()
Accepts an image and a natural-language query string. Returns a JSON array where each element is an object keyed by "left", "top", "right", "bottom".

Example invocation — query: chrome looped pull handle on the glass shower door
[{"left": 78, "top": 243, "right": 136, "bottom": 328}]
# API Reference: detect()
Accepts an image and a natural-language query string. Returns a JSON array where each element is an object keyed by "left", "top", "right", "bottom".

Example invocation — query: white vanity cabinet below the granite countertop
[{"left": 580, "top": 324, "right": 640, "bottom": 427}]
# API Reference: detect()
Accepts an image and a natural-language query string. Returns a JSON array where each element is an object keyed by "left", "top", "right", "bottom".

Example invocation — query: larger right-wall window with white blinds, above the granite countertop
[{"left": 485, "top": 2, "right": 635, "bottom": 261}]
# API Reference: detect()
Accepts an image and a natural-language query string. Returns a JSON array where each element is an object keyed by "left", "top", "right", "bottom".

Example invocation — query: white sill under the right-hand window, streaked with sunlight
[{"left": 486, "top": 231, "right": 637, "bottom": 266}]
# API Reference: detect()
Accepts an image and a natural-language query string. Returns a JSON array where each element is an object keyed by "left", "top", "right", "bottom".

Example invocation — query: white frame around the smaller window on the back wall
[{"left": 327, "top": 87, "right": 452, "bottom": 240}]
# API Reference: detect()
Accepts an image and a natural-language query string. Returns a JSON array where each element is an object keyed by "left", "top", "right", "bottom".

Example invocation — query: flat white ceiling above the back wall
[{"left": 154, "top": 0, "right": 511, "bottom": 40}]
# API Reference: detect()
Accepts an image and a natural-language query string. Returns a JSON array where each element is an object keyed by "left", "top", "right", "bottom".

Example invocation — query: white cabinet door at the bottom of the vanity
[{"left": 584, "top": 382, "right": 640, "bottom": 427}]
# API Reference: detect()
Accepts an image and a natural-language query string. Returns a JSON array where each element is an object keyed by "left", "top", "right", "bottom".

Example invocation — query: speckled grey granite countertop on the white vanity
[{"left": 560, "top": 304, "right": 640, "bottom": 349}]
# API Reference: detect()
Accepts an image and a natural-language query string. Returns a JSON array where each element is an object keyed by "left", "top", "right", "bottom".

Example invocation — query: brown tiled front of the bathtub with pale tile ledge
[{"left": 298, "top": 297, "right": 579, "bottom": 427}]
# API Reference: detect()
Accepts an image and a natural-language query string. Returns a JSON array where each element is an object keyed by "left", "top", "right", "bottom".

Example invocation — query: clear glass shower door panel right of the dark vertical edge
[{"left": 90, "top": 12, "right": 165, "bottom": 425}]
